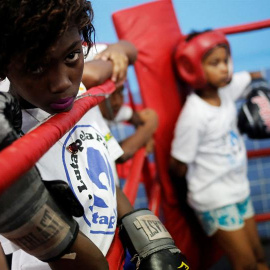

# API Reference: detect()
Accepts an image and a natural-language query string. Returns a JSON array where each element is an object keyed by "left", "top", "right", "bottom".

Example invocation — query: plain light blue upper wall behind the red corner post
[{"left": 91, "top": 0, "right": 270, "bottom": 71}]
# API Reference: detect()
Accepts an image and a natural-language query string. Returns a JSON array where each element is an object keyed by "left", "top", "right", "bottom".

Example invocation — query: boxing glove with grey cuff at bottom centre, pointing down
[{"left": 119, "top": 209, "right": 189, "bottom": 270}]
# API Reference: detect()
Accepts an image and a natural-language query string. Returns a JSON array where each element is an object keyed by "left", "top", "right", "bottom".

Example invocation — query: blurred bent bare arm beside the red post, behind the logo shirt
[{"left": 117, "top": 109, "right": 158, "bottom": 163}]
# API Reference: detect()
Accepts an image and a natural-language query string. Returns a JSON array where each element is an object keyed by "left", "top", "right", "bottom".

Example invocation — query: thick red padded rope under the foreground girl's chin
[{"left": 0, "top": 80, "right": 115, "bottom": 193}]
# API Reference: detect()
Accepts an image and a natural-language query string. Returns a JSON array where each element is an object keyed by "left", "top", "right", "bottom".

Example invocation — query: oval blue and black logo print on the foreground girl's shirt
[{"left": 62, "top": 125, "right": 117, "bottom": 234}]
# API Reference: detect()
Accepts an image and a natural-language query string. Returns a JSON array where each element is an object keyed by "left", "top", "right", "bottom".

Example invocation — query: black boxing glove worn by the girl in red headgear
[{"left": 238, "top": 79, "right": 270, "bottom": 139}]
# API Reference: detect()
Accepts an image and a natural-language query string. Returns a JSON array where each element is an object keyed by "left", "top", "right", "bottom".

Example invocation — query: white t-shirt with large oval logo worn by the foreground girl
[{"left": 1, "top": 83, "right": 123, "bottom": 270}]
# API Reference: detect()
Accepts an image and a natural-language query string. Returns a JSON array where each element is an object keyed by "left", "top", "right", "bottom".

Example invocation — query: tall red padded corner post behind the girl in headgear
[{"left": 113, "top": 0, "right": 223, "bottom": 269}]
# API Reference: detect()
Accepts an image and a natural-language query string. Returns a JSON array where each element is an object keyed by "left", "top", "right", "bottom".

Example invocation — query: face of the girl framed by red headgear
[{"left": 202, "top": 47, "right": 230, "bottom": 88}]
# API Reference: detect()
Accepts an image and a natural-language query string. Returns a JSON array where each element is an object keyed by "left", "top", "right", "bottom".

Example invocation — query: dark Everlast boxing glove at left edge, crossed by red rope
[{"left": 0, "top": 93, "right": 79, "bottom": 261}]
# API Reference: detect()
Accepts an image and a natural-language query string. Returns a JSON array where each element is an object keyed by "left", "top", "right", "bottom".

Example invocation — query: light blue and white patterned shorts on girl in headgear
[{"left": 196, "top": 196, "right": 254, "bottom": 236}]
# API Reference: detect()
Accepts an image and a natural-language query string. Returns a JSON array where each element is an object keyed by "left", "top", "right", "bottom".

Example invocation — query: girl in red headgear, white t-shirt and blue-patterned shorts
[{"left": 170, "top": 31, "right": 268, "bottom": 269}]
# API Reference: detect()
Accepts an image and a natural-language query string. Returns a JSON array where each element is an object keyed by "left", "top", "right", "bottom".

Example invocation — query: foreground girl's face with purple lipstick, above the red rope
[{"left": 7, "top": 27, "right": 84, "bottom": 114}]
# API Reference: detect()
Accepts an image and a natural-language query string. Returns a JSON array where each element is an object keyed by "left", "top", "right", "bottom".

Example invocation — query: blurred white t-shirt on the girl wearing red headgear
[{"left": 171, "top": 72, "right": 251, "bottom": 211}]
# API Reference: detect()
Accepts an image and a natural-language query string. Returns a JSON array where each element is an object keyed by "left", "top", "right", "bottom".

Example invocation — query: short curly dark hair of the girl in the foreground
[{"left": 0, "top": 0, "right": 94, "bottom": 80}]
